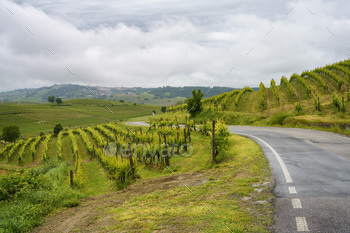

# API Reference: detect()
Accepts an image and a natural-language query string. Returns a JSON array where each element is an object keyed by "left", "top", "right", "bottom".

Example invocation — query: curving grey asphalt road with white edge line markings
[{"left": 229, "top": 126, "right": 350, "bottom": 233}]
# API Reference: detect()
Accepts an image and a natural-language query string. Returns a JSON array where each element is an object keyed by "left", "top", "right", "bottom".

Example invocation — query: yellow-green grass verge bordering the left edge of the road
[{"left": 99, "top": 135, "right": 273, "bottom": 232}]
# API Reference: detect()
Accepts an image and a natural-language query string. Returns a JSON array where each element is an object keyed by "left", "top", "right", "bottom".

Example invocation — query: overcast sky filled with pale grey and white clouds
[{"left": 0, "top": 0, "right": 350, "bottom": 92}]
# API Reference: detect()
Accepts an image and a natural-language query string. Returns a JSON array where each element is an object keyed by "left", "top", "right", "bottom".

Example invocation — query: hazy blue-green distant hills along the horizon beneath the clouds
[{"left": 0, "top": 84, "right": 234, "bottom": 105}]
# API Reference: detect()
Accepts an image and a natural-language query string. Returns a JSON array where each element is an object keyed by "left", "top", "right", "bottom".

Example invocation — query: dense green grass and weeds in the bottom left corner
[{"left": 0, "top": 161, "right": 84, "bottom": 233}]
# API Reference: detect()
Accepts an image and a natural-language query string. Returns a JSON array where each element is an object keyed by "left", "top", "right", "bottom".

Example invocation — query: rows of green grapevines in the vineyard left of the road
[{"left": 0, "top": 119, "right": 228, "bottom": 187}]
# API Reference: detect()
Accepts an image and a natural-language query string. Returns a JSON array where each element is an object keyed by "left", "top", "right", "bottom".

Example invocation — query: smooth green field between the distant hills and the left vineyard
[{"left": 0, "top": 100, "right": 160, "bottom": 138}]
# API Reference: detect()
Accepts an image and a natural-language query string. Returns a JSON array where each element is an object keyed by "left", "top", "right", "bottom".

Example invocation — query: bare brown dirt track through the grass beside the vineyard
[{"left": 33, "top": 171, "right": 209, "bottom": 233}]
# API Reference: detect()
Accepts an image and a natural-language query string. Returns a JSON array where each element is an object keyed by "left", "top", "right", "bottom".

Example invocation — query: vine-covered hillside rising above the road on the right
[{"left": 168, "top": 60, "right": 350, "bottom": 133}]
